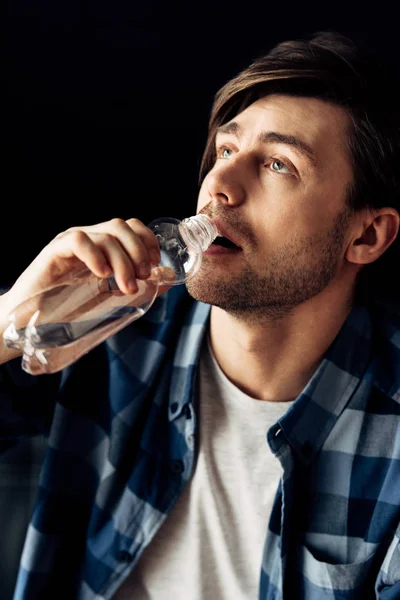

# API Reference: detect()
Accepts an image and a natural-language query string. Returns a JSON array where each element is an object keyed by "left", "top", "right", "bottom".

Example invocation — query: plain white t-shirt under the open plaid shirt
[{"left": 114, "top": 340, "right": 293, "bottom": 600}]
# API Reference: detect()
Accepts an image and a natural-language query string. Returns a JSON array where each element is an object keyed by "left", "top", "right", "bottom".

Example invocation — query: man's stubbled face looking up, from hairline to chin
[{"left": 187, "top": 95, "right": 352, "bottom": 317}]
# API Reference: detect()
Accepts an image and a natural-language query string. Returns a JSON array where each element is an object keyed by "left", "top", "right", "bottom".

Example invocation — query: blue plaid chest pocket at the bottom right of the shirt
[{"left": 297, "top": 545, "right": 376, "bottom": 600}]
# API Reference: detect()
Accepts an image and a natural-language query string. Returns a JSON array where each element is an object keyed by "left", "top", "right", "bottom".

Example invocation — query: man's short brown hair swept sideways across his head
[{"left": 200, "top": 31, "right": 400, "bottom": 308}]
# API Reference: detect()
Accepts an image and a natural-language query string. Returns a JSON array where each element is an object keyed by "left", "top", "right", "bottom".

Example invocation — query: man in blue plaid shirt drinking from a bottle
[{"left": 0, "top": 34, "right": 400, "bottom": 600}]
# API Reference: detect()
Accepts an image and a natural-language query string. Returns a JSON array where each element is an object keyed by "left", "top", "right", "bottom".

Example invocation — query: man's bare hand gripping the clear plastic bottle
[{"left": 7, "top": 219, "right": 170, "bottom": 306}]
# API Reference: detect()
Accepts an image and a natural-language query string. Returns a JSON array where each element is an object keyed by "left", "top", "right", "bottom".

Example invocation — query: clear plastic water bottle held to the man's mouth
[{"left": 3, "top": 214, "right": 218, "bottom": 375}]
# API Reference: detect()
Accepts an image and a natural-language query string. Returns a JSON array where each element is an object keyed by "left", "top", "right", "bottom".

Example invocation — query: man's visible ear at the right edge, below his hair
[{"left": 345, "top": 207, "right": 400, "bottom": 265}]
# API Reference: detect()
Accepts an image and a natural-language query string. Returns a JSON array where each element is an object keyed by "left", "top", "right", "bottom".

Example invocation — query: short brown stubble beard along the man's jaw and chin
[{"left": 186, "top": 208, "right": 349, "bottom": 322}]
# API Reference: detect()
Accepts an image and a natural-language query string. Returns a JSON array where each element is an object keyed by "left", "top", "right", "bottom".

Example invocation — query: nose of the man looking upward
[{"left": 207, "top": 160, "right": 245, "bottom": 206}]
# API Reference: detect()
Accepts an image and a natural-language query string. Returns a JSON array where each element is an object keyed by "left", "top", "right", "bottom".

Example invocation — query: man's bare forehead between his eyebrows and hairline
[{"left": 220, "top": 94, "right": 350, "bottom": 160}]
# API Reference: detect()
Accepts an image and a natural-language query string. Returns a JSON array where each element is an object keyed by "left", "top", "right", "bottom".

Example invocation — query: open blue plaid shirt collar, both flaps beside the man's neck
[{"left": 169, "top": 294, "right": 400, "bottom": 464}]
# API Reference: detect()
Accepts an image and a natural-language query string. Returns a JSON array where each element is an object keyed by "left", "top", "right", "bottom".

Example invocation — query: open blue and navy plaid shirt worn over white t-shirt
[{"left": 0, "top": 286, "right": 400, "bottom": 600}]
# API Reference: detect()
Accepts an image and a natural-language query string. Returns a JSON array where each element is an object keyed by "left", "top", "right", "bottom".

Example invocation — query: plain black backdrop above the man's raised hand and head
[{"left": 4, "top": 0, "right": 400, "bottom": 285}]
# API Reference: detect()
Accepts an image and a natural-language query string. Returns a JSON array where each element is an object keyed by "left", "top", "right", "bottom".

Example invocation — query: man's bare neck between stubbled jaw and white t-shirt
[{"left": 210, "top": 288, "right": 353, "bottom": 402}]
